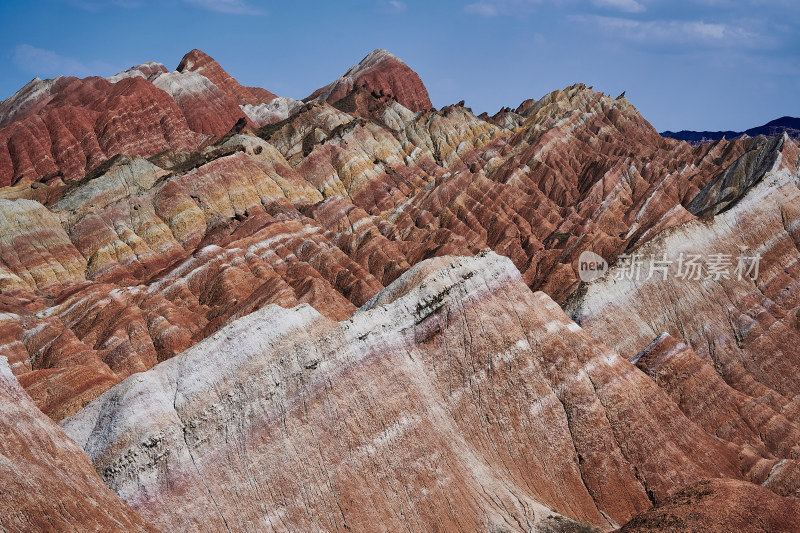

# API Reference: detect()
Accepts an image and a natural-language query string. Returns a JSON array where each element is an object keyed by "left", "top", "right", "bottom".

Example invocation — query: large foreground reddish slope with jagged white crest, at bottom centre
[{"left": 63, "top": 252, "right": 752, "bottom": 531}]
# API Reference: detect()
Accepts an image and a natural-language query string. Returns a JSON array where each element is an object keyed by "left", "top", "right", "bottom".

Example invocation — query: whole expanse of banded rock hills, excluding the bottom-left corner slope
[{"left": 0, "top": 50, "right": 800, "bottom": 531}]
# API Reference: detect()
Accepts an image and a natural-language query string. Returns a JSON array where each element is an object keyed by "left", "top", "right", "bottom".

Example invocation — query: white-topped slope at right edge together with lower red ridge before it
[{"left": 569, "top": 138, "right": 800, "bottom": 495}]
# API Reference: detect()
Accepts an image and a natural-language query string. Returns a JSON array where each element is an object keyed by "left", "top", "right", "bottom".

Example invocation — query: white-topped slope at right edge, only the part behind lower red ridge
[{"left": 571, "top": 140, "right": 800, "bottom": 424}]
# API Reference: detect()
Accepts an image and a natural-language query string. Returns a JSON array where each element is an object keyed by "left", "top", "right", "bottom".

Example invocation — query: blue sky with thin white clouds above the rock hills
[{"left": 0, "top": 0, "right": 800, "bottom": 130}]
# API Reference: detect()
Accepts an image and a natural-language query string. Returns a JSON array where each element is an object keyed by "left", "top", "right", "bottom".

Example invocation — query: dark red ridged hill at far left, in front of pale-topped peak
[{"left": 0, "top": 77, "right": 202, "bottom": 186}]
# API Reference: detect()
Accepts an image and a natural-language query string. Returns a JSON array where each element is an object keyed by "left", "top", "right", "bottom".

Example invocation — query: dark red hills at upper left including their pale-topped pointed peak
[{"left": 0, "top": 50, "right": 282, "bottom": 186}]
